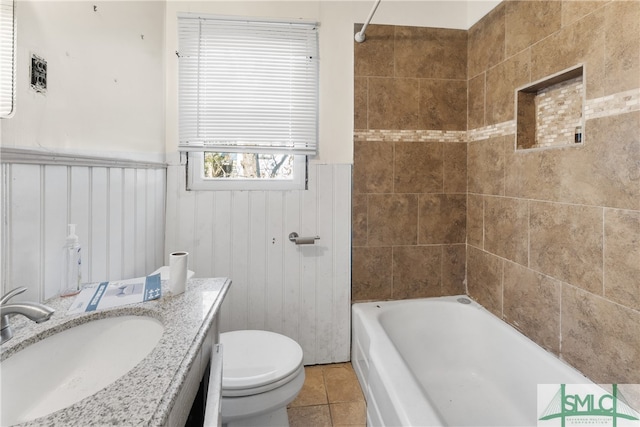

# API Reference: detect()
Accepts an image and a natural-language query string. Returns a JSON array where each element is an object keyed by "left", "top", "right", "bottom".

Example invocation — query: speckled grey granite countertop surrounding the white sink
[{"left": 0, "top": 278, "right": 231, "bottom": 426}]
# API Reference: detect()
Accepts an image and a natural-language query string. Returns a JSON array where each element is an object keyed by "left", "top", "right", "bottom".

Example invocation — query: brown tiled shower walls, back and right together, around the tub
[{"left": 352, "top": 0, "right": 640, "bottom": 383}]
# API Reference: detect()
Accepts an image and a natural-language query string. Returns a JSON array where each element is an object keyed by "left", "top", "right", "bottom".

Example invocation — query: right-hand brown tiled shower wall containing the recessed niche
[{"left": 467, "top": 1, "right": 640, "bottom": 383}]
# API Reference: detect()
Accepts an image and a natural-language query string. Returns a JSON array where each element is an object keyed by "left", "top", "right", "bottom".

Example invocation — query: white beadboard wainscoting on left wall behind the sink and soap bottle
[{"left": 1, "top": 149, "right": 167, "bottom": 301}]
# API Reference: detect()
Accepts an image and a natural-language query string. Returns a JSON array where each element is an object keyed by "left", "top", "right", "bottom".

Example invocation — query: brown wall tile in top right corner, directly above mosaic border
[{"left": 605, "top": 1, "right": 640, "bottom": 95}]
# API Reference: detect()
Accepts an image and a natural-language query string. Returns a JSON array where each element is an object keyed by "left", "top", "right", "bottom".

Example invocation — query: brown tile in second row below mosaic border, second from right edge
[{"left": 529, "top": 201, "right": 603, "bottom": 294}]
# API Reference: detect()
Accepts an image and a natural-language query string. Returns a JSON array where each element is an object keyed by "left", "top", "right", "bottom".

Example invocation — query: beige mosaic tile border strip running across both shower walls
[{"left": 353, "top": 88, "right": 640, "bottom": 142}]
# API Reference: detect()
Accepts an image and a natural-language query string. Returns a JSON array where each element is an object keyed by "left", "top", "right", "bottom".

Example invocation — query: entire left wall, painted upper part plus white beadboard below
[{"left": 0, "top": 0, "right": 166, "bottom": 300}]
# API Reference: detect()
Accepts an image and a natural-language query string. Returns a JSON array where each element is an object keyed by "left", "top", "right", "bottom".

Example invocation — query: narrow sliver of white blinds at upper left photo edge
[{"left": 0, "top": 0, "right": 15, "bottom": 117}]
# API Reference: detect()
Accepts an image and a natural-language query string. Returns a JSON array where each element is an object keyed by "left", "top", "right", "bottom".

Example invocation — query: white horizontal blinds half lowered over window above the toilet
[{"left": 177, "top": 15, "right": 318, "bottom": 155}]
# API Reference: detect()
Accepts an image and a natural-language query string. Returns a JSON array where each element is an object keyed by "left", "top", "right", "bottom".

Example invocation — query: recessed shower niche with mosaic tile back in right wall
[{"left": 515, "top": 65, "right": 585, "bottom": 150}]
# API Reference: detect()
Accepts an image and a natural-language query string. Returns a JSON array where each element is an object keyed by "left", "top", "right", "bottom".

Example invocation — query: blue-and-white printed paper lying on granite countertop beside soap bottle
[{"left": 67, "top": 274, "right": 162, "bottom": 314}]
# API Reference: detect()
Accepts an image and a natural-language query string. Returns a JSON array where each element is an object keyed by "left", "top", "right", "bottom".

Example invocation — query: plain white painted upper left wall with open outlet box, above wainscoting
[{"left": 0, "top": 0, "right": 164, "bottom": 161}]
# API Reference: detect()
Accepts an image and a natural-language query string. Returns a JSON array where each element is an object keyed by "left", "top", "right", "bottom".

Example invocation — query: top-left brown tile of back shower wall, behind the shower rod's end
[{"left": 353, "top": 25, "right": 395, "bottom": 77}]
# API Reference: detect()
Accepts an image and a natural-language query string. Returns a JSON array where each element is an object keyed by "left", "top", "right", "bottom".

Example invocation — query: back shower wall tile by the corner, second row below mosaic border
[{"left": 418, "top": 194, "right": 467, "bottom": 245}]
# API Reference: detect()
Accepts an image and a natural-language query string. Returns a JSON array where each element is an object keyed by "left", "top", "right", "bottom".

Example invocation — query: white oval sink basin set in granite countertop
[{"left": 0, "top": 316, "right": 164, "bottom": 426}]
